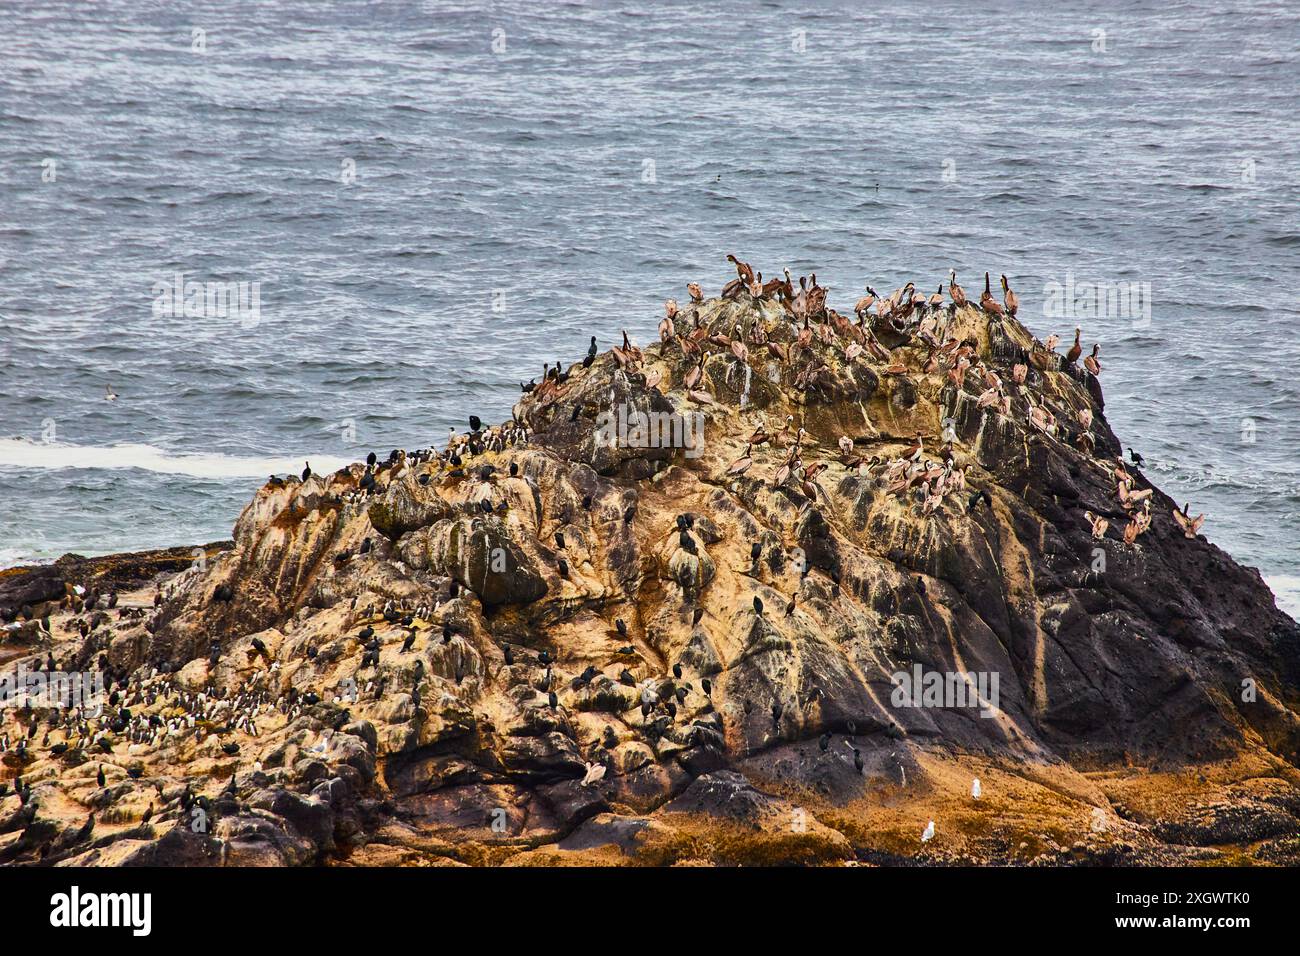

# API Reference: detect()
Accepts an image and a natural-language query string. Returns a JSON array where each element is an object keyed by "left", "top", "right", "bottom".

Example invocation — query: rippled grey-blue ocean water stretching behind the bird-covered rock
[{"left": 0, "top": 0, "right": 1300, "bottom": 613}]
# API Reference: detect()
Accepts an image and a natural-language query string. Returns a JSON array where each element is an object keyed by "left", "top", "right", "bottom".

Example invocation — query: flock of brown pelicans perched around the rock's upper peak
[{"left": 644, "top": 255, "right": 1204, "bottom": 544}]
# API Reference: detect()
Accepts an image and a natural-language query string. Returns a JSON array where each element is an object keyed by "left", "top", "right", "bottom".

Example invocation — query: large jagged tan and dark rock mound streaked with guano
[{"left": 0, "top": 283, "right": 1300, "bottom": 865}]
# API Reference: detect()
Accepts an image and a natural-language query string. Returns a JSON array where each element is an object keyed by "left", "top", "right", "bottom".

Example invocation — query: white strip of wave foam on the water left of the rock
[{"left": 0, "top": 438, "right": 355, "bottom": 479}]
